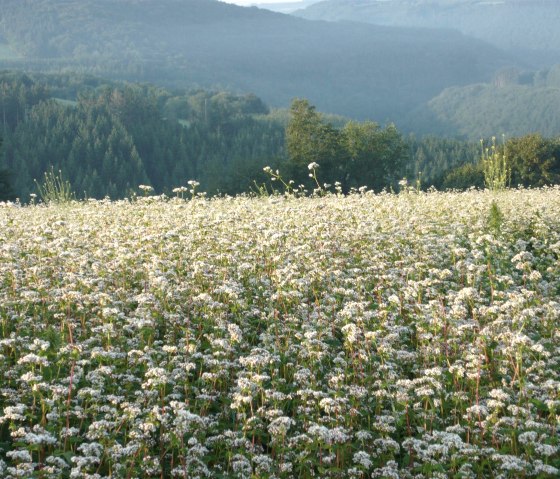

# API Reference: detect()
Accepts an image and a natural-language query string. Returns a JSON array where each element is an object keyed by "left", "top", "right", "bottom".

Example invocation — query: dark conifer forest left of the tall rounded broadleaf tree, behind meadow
[{"left": 0, "top": 73, "right": 284, "bottom": 198}]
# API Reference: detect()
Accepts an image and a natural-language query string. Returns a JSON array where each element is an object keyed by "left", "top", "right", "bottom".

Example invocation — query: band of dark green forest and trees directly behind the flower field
[{"left": 0, "top": 71, "right": 560, "bottom": 202}]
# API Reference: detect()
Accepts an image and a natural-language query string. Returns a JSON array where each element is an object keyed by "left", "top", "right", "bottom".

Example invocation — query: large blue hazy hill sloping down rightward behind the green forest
[{"left": 0, "top": 0, "right": 511, "bottom": 122}]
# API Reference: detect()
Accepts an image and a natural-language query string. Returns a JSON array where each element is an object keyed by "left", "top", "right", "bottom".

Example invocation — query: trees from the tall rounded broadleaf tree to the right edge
[{"left": 286, "top": 99, "right": 560, "bottom": 191}]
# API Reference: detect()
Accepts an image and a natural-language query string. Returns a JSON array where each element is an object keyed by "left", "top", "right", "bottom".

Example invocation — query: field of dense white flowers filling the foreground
[{"left": 0, "top": 187, "right": 560, "bottom": 479}]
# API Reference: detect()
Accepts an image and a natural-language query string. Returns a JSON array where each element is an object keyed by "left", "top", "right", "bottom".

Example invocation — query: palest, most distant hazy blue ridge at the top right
[{"left": 296, "top": 0, "right": 560, "bottom": 66}]
